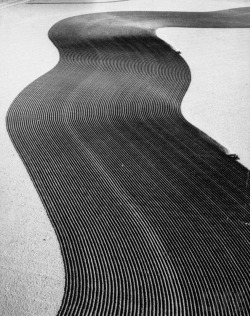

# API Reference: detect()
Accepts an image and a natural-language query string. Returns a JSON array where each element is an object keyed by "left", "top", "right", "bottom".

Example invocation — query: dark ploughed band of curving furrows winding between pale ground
[{"left": 7, "top": 9, "right": 250, "bottom": 316}]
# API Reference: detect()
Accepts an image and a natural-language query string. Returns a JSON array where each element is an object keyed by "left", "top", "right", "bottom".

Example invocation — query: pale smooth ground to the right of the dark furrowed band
[{"left": 157, "top": 28, "right": 250, "bottom": 169}]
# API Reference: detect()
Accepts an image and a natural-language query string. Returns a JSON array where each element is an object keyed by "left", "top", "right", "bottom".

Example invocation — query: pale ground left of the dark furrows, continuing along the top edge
[{"left": 0, "top": 0, "right": 250, "bottom": 316}]
